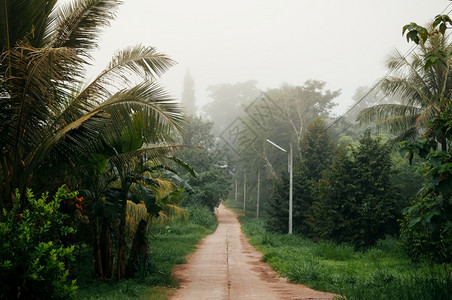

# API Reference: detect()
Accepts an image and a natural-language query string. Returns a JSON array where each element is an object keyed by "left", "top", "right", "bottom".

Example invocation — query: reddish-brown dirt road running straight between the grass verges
[{"left": 172, "top": 205, "right": 334, "bottom": 300}]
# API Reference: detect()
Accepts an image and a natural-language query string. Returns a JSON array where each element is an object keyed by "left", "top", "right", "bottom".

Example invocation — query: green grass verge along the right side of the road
[{"left": 239, "top": 216, "right": 452, "bottom": 300}]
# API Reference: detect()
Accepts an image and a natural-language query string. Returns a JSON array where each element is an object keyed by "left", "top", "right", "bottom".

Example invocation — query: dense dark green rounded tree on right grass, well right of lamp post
[{"left": 312, "top": 131, "right": 403, "bottom": 247}]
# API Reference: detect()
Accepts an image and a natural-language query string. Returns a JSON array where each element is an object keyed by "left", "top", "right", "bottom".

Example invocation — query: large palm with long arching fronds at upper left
[{"left": 0, "top": 0, "right": 183, "bottom": 208}]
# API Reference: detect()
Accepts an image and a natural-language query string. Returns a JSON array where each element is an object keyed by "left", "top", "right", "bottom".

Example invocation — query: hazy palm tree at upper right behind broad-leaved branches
[{"left": 358, "top": 23, "right": 452, "bottom": 144}]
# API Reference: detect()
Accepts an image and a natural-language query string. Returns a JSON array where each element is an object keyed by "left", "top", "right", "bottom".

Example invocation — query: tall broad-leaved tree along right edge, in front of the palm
[{"left": 396, "top": 15, "right": 452, "bottom": 263}]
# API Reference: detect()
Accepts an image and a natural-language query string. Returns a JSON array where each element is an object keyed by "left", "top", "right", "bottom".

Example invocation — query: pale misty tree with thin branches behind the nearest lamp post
[{"left": 235, "top": 80, "right": 340, "bottom": 219}]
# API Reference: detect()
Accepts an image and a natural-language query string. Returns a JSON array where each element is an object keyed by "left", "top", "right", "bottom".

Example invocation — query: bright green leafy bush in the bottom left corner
[{"left": 0, "top": 187, "right": 77, "bottom": 299}]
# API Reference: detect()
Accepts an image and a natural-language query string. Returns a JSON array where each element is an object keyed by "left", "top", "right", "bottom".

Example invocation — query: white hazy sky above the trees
[{"left": 86, "top": 0, "right": 452, "bottom": 113}]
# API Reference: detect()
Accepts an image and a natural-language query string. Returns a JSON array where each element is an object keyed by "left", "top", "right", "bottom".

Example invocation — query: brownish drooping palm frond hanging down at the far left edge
[{"left": 2, "top": 44, "right": 82, "bottom": 153}]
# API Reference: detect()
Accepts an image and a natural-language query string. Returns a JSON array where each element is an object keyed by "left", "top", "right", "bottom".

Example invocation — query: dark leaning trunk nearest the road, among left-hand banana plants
[{"left": 126, "top": 219, "right": 148, "bottom": 277}]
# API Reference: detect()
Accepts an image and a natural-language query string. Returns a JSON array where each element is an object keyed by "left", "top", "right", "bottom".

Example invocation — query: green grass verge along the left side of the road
[{"left": 73, "top": 208, "right": 216, "bottom": 299}]
